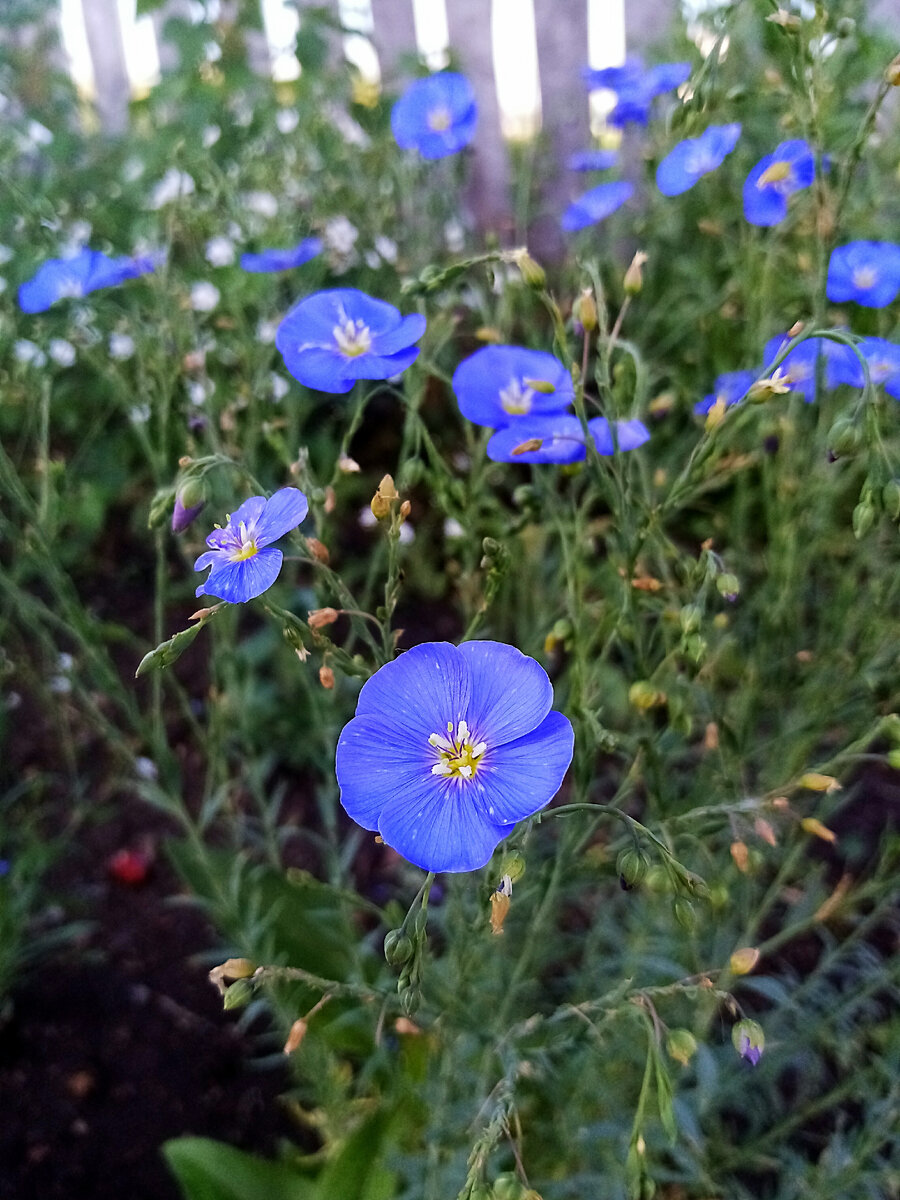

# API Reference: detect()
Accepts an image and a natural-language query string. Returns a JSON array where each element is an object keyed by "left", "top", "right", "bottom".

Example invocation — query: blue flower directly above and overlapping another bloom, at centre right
[{"left": 452, "top": 346, "right": 575, "bottom": 428}]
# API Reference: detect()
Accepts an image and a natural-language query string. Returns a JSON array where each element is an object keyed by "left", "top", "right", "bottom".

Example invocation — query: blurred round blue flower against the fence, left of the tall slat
[{"left": 391, "top": 71, "right": 478, "bottom": 158}]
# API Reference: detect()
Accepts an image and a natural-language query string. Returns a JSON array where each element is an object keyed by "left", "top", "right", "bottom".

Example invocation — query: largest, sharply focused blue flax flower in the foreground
[{"left": 335, "top": 642, "right": 575, "bottom": 871}]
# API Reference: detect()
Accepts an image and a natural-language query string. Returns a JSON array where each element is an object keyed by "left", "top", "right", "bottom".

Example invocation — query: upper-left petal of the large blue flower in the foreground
[{"left": 356, "top": 642, "right": 470, "bottom": 749}]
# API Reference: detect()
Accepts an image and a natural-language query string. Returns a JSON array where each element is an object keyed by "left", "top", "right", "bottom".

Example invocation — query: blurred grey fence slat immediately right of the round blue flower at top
[{"left": 446, "top": 0, "right": 512, "bottom": 241}]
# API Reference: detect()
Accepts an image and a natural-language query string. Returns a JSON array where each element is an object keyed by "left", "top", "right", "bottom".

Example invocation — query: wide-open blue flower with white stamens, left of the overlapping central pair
[{"left": 275, "top": 288, "right": 425, "bottom": 392}]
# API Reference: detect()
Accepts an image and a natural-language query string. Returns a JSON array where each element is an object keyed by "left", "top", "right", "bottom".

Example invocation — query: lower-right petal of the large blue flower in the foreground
[{"left": 470, "top": 712, "right": 575, "bottom": 824}]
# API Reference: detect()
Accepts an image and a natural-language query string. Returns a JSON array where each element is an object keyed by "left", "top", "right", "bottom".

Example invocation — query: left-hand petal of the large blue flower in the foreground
[{"left": 335, "top": 714, "right": 438, "bottom": 829}]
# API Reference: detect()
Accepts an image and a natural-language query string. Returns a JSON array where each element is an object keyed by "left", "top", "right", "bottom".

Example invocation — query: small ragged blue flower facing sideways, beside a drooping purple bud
[{"left": 193, "top": 487, "right": 310, "bottom": 604}]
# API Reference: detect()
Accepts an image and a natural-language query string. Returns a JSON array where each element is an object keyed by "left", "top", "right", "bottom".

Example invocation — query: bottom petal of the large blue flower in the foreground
[{"left": 378, "top": 775, "right": 509, "bottom": 871}]
